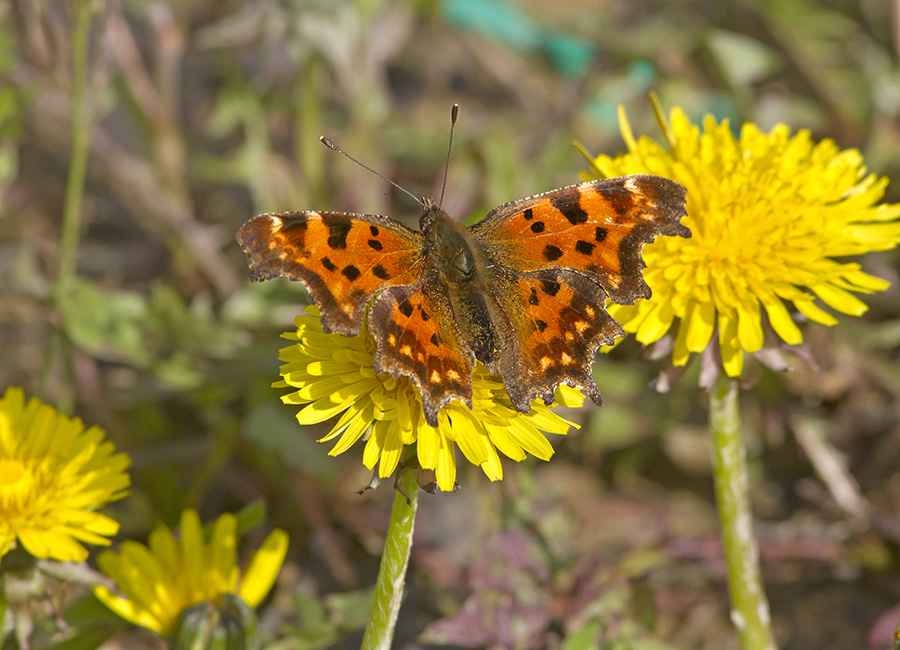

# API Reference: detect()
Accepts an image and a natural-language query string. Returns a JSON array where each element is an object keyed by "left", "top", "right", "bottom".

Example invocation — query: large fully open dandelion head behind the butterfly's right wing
[{"left": 580, "top": 98, "right": 900, "bottom": 377}]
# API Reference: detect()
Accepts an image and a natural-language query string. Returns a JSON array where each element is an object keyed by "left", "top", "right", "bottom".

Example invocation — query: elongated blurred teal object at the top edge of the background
[{"left": 442, "top": 0, "right": 597, "bottom": 77}]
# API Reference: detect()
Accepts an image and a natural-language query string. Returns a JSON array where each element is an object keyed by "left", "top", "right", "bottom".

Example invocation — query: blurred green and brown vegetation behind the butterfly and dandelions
[{"left": 0, "top": 0, "right": 900, "bottom": 650}]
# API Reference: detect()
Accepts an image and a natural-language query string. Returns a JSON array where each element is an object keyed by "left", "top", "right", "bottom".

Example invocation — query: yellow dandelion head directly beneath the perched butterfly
[{"left": 273, "top": 307, "right": 584, "bottom": 492}]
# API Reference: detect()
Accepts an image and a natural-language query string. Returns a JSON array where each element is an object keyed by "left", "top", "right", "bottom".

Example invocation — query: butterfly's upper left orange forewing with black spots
[{"left": 237, "top": 211, "right": 422, "bottom": 336}]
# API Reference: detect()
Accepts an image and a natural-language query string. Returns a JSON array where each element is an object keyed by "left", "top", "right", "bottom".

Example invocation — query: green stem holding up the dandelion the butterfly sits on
[{"left": 360, "top": 470, "right": 419, "bottom": 650}]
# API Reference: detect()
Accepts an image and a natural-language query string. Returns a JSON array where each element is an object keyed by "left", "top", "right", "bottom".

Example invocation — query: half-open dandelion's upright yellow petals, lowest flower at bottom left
[{"left": 94, "top": 510, "right": 288, "bottom": 636}]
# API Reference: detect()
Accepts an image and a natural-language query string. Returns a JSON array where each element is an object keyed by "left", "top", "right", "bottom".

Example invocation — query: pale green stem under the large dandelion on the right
[{"left": 709, "top": 375, "right": 777, "bottom": 650}]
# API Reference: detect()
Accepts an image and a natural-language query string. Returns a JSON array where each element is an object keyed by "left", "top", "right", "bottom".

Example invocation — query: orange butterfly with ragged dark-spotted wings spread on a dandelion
[{"left": 237, "top": 170, "right": 691, "bottom": 426}]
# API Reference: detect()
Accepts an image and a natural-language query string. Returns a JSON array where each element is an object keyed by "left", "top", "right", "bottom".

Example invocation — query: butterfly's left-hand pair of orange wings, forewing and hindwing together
[{"left": 237, "top": 212, "right": 475, "bottom": 426}]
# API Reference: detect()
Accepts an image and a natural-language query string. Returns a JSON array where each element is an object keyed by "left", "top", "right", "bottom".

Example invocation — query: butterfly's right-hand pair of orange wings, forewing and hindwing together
[{"left": 471, "top": 175, "right": 690, "bottom": 411}]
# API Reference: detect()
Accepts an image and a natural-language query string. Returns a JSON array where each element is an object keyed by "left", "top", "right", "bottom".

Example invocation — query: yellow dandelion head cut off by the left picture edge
[{"left": 0, "top": 387, "right": 131, "bottom": 562}]
